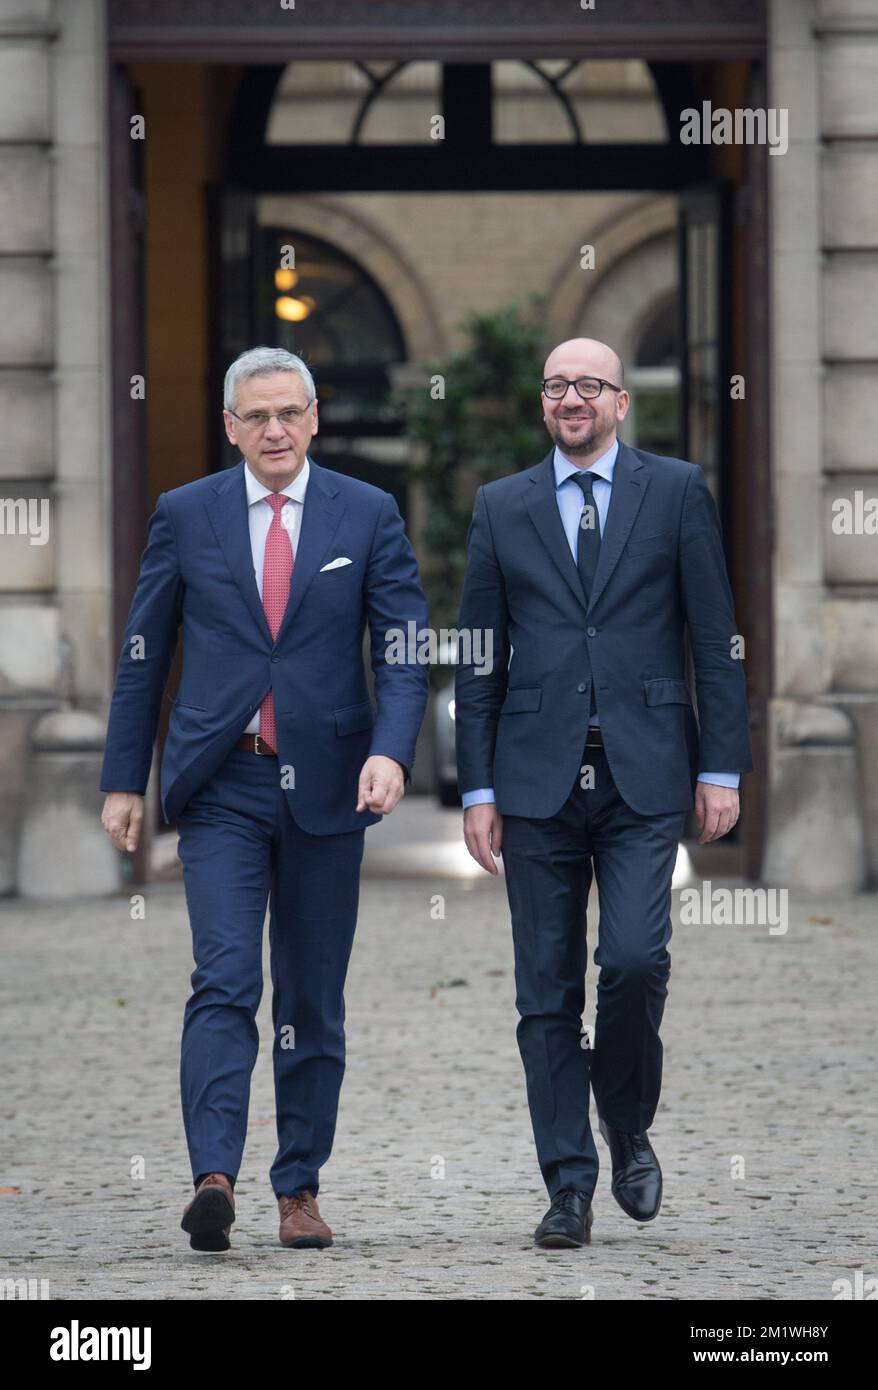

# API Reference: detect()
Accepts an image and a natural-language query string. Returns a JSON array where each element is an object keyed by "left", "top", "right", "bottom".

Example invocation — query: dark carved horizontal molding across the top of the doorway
[{"left": 107, "top": 0, "right": 767, "bottom": 63}]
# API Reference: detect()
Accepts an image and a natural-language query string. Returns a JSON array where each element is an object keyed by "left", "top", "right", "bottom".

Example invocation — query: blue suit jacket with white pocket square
[{"left": 100, "top": 459, "right": 428, "bottom": 835}]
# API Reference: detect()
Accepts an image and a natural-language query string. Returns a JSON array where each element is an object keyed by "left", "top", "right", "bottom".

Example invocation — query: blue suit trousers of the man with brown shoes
[{"left": 176, "top": 749, "right": 365, "bottom": 1195}]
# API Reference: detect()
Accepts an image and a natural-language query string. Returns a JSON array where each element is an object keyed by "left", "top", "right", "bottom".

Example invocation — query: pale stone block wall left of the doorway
[{"left": 0, "top": 0, "right": 113, "bottom": 897}]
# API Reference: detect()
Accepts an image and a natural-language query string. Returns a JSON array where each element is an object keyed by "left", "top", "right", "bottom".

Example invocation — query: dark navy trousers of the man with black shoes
[{"left": 503, "top": 746, "right": 685, "bottom": 1197}]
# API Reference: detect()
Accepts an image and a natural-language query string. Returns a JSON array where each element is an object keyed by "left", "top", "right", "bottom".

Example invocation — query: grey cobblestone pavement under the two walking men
[{"left": 0, "top": 811, "right": 878, "bottom": 1300}]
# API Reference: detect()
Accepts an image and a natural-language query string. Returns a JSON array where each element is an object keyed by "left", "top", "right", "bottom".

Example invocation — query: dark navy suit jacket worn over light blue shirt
[{"left": 456, "top": 443, "right": 753, "bottom": 817}]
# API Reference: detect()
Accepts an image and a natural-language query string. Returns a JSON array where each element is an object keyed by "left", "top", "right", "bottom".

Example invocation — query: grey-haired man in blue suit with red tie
[{"left": 100, "top": 348, "right": 428, "bottom": 1251}]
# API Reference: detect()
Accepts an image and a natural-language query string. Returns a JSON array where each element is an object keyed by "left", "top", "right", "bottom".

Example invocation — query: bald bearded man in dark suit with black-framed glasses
[{"left": 456, "top": 338, "right": 753, "bottom": 1247}]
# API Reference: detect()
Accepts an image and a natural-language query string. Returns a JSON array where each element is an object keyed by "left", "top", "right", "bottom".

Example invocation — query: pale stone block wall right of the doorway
[{"left": 765, "top": 0, "right": 878, "bottom": 891}]
